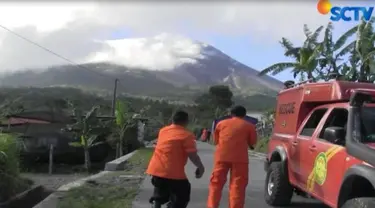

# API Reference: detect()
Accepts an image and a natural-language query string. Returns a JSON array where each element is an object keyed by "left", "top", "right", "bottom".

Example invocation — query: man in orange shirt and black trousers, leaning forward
[{"left": 146, "top": 111, "right": 204, "bottom": 208}]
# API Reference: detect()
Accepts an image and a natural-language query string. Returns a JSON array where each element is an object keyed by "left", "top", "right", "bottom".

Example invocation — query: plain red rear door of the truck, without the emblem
[{"left": 291, "top": 108, "right": 327, "bottom": 189}]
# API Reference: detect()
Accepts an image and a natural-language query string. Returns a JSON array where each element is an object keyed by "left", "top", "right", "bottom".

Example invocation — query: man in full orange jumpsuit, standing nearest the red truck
[{"left": 207, "top": 106, "right": 257, "bottom": 208}]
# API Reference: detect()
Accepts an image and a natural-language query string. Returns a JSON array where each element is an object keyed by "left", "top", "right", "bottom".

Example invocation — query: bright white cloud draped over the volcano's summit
[{"left": 87, "top": 33, "right": 206, "bottom": 70}]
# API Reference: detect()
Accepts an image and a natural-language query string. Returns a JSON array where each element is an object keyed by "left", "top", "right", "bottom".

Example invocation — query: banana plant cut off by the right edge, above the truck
[{"left": 355, "top": 18, "right": 375, "bottom": 82}]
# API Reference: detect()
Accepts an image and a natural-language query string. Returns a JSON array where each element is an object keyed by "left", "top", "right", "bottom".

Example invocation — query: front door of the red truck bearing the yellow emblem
[{"left": 307, "top": 106, "right": 348, "bottom": 205}]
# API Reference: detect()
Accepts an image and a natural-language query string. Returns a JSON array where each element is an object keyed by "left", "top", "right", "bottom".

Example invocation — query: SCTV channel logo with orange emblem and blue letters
[{"left": 317, "top": 0, "right": 374, "bottom": 22}]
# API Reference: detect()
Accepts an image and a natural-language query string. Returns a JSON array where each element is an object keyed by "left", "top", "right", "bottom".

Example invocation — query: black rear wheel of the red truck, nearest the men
[{"left": 264, "top": 162, "right": 293, "bottom": 206}]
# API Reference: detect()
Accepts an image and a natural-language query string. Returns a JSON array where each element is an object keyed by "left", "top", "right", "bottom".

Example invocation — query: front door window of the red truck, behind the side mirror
[{"left": 319, "top": 108, "right": 349, "bottom": 140}]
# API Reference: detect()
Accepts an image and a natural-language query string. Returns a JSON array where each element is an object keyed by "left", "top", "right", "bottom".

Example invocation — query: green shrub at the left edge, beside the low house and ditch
[{"left": 0, "top": 134, "right": 30, "bottom": 202}]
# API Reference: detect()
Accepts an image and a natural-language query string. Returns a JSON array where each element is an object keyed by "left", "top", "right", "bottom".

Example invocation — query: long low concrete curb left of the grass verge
[{"left": 33, "top": 150, "right": 138, "bottom": 208}]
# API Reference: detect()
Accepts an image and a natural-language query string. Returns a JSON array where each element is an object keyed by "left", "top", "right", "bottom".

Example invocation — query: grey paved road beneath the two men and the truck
[{"left": 133, "top": 142, "right": 325, "bottom": 208}]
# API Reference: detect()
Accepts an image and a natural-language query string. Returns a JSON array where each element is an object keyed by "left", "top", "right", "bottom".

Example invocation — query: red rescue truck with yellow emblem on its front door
[{"left": 265, "top": 80, "right": 375, "bottom": 208}]
